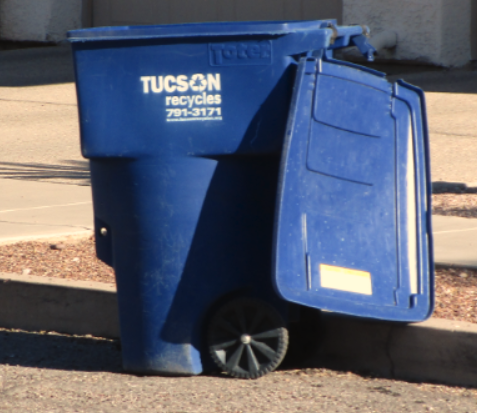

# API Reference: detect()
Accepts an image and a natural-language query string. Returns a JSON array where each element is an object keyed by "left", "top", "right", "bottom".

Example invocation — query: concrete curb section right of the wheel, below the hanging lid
[{"left": 315, "top": 313, "right": 477, "bottom": 386}]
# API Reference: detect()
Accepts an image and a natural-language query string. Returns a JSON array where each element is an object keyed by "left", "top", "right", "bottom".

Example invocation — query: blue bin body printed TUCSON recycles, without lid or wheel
[{"left": 69, "top": 22, "right": 333, "bottom": 375}]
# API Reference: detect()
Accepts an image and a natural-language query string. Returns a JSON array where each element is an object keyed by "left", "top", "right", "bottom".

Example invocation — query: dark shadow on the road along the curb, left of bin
[{"left": 0, "top": 330, "right": 122, "bottom": 372}]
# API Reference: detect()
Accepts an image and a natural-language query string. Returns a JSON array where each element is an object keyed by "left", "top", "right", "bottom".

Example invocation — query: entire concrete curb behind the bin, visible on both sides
[{"left": 0, "top": 273, "right": 477, "bottom": 386}]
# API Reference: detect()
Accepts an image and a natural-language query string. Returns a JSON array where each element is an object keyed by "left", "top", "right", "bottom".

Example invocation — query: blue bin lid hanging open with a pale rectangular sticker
[{"left": 273, "top": 57, "right": 434, "bottom": 321}]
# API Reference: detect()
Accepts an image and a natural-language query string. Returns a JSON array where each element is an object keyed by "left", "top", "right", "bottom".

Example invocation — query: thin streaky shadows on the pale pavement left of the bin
[{"left": 0, "top": 160, "right": 91, "bottom": 186}]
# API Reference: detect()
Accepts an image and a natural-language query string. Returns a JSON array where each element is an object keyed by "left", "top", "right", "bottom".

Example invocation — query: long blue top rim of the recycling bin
[{"left": 67, "top": 19, "right": 336, "bottom": 42}]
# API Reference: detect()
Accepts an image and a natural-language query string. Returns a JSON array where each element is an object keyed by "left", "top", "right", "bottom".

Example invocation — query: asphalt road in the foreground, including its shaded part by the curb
[{"left": 0, "top": 329, "right": 477, "bottom": 413}]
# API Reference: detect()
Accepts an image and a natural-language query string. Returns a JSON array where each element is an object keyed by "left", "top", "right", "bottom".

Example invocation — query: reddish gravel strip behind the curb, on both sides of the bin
[{"left": 0, "top": 232, "right": 477, "bottom": 323}]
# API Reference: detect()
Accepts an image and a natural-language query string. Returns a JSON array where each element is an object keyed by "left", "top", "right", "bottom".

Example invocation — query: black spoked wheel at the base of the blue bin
[{"left": 207, "top": 298, "right": 288, "bottom": 379}]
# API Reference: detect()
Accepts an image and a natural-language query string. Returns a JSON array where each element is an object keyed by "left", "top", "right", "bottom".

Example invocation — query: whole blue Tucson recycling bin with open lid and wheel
[{"left": 69, "top": 20, "right": 432, "bottom": 378}]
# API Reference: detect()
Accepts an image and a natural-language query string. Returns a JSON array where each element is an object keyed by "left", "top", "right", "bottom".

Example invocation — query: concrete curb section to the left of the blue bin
[{"left": 0, "top": 273, "right": 119, "bottom": 337}]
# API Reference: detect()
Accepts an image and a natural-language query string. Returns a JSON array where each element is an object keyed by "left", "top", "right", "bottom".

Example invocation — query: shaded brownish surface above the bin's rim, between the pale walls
[{"left": 83, "top": 0, "right": 342, "bottom": 27}]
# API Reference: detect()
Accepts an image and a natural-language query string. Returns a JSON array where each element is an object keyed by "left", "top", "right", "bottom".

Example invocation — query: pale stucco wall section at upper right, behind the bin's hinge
[{"left": 343, "top": 0, "right": 475, "bottom": 66}]
